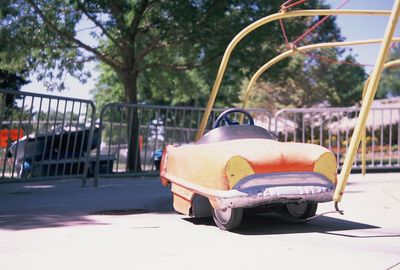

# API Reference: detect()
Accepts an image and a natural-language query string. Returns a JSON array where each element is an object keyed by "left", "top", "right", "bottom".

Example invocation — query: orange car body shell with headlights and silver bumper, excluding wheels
[{"left": 160, "top": 135, "right": 336, "bottom": 215}]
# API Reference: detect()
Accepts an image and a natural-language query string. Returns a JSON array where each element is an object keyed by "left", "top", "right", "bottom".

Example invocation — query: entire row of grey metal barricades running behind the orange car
[{"left": 0, "top": 90, "right": 400, "bottom": 184}]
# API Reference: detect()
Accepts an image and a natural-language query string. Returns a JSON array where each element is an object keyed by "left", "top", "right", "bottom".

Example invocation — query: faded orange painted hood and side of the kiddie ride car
[{"left": 161, "top": 139, "right": 336, "bottom": 190}]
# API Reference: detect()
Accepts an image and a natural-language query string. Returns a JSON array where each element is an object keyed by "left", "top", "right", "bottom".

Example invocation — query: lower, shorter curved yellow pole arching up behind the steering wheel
[{"left": 242, "top": 37, "right": 400, "bottom": 109}]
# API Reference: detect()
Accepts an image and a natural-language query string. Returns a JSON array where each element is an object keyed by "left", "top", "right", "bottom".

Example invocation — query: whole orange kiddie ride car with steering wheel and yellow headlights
[{"left": 160, "top": 109, "right": 337, "bottom": 230}]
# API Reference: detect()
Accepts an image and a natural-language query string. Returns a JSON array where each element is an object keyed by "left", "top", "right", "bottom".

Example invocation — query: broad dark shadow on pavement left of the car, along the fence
[{"left": 0, "top": 179, "right": 172, "bottom": 230}]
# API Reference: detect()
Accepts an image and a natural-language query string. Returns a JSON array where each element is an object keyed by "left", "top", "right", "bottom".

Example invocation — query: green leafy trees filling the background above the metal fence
[{"left": 0, "top": 0, "right": 365, "bottom": 108}]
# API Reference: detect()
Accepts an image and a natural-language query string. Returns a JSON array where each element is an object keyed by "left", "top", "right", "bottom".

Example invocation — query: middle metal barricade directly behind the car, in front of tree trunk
[{"left": 95, "top": 103, "right": 271, "bottom": 184}]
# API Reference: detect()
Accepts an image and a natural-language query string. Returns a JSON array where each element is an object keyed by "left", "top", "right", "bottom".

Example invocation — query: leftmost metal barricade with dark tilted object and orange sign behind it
[{"left": 0, "top": 90, "right": 97, "bottom": 183}]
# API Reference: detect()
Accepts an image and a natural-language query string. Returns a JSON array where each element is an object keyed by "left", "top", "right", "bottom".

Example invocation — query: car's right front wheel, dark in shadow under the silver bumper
[{"left": 283, "top": 202, "right": 318, "bottom": 222}]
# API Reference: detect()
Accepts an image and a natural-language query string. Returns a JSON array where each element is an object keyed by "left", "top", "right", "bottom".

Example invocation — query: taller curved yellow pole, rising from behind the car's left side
[{"left": 196, "top": 9, "right": 391, "bottom": 140}]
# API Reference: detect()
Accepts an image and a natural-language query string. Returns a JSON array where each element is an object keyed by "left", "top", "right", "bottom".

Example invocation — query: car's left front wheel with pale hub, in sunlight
[{"left": 212, "top": 208, "right": 243, "bottom": 231}]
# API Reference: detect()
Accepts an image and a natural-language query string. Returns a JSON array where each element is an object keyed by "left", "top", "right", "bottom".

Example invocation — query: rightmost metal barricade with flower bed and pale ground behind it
[{"left": 271, "top": 107, "right": 400, "bottom": 169}]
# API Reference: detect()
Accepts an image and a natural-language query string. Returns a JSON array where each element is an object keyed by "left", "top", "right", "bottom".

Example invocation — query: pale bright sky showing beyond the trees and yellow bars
[{"left": 22, "top": 0, "right": 400, "bottom": 99}]
